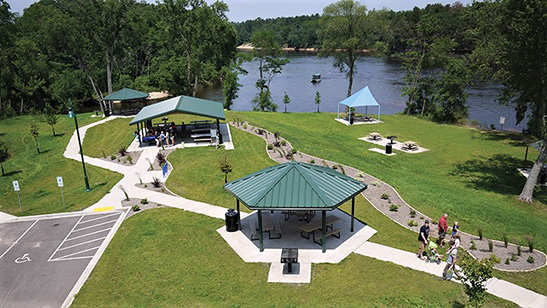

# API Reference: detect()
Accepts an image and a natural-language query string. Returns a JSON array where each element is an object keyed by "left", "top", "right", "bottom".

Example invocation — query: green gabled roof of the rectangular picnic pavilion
[{"left": 129, "top": 95, "right": 226, "bottom": 125}]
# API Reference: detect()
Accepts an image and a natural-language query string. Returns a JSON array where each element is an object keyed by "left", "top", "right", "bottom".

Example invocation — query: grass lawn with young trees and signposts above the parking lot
[{"left": 0, "top": 114, "right": 122, "bottom": 215}]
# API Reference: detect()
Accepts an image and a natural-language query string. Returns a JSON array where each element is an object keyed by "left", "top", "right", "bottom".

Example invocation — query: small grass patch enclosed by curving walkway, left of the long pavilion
[{"left": 83, "top": 118, "right": 137, "bottom": 157}]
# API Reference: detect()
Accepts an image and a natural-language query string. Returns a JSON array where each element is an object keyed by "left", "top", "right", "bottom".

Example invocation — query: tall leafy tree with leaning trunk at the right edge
[{"left": 472, "top": 0, "right": 547, "bottom": 202}]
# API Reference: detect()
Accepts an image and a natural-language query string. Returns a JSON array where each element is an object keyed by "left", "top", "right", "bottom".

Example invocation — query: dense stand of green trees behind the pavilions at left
[{"left": 0, "top": 0, "right": 236, "bottom": 115}]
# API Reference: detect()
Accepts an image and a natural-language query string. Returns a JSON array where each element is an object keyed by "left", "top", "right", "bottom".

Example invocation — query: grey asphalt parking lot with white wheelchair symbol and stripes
[{"left": 0, "top": 211, "right": 123, "bottom": 308}]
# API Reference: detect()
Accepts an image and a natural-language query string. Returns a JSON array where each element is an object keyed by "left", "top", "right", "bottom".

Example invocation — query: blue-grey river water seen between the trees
[{"left": 199, "top": 52, "right": 525, "bottom": 130}]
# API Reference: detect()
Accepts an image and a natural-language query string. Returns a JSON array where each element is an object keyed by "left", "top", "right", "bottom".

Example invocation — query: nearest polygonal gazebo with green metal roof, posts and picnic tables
[{"left": 224, "top": 161, "right": 367, "bottom": 252}]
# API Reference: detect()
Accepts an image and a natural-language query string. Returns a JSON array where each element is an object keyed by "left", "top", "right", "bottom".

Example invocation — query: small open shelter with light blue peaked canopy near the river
[{"left": 336, "top": 86, "right": 380, "bottom": 125}]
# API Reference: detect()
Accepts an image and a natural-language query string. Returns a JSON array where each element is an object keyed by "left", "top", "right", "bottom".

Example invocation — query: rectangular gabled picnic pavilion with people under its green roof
[{"left": 129, "top": 95, "right": 229, "bottom": 145}]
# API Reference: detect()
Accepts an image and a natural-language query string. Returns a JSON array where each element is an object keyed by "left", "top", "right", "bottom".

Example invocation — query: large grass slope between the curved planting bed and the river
[{"left": 237, "top": 112, "right": 547, "bottom": 251}]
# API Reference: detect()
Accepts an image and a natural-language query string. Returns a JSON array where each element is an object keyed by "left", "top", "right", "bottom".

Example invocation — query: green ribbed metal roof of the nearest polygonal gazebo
[{"left": 224, "top": 162, "right": 367, "bottom": 210}]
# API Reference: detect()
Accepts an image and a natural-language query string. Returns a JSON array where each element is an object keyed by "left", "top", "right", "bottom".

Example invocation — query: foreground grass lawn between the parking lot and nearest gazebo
[{"left": 73, "top": 208, "right": 514, "bottom": 307}]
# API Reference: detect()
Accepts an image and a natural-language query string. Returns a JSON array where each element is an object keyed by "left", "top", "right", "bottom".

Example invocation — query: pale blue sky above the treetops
[{"left": 8, "top": 0, "right": 472, "bottom": 21}]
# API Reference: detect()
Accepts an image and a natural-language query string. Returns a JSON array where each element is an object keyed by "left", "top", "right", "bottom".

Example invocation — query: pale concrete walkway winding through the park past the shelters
[{"left": 9, "top": 117, "right": 547, "bottom": 307}]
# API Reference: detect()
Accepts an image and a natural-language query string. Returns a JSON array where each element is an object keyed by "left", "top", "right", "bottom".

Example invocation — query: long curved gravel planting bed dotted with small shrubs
[{"left": 230, "top": 121, "right": 547, "bottom": 272}]
